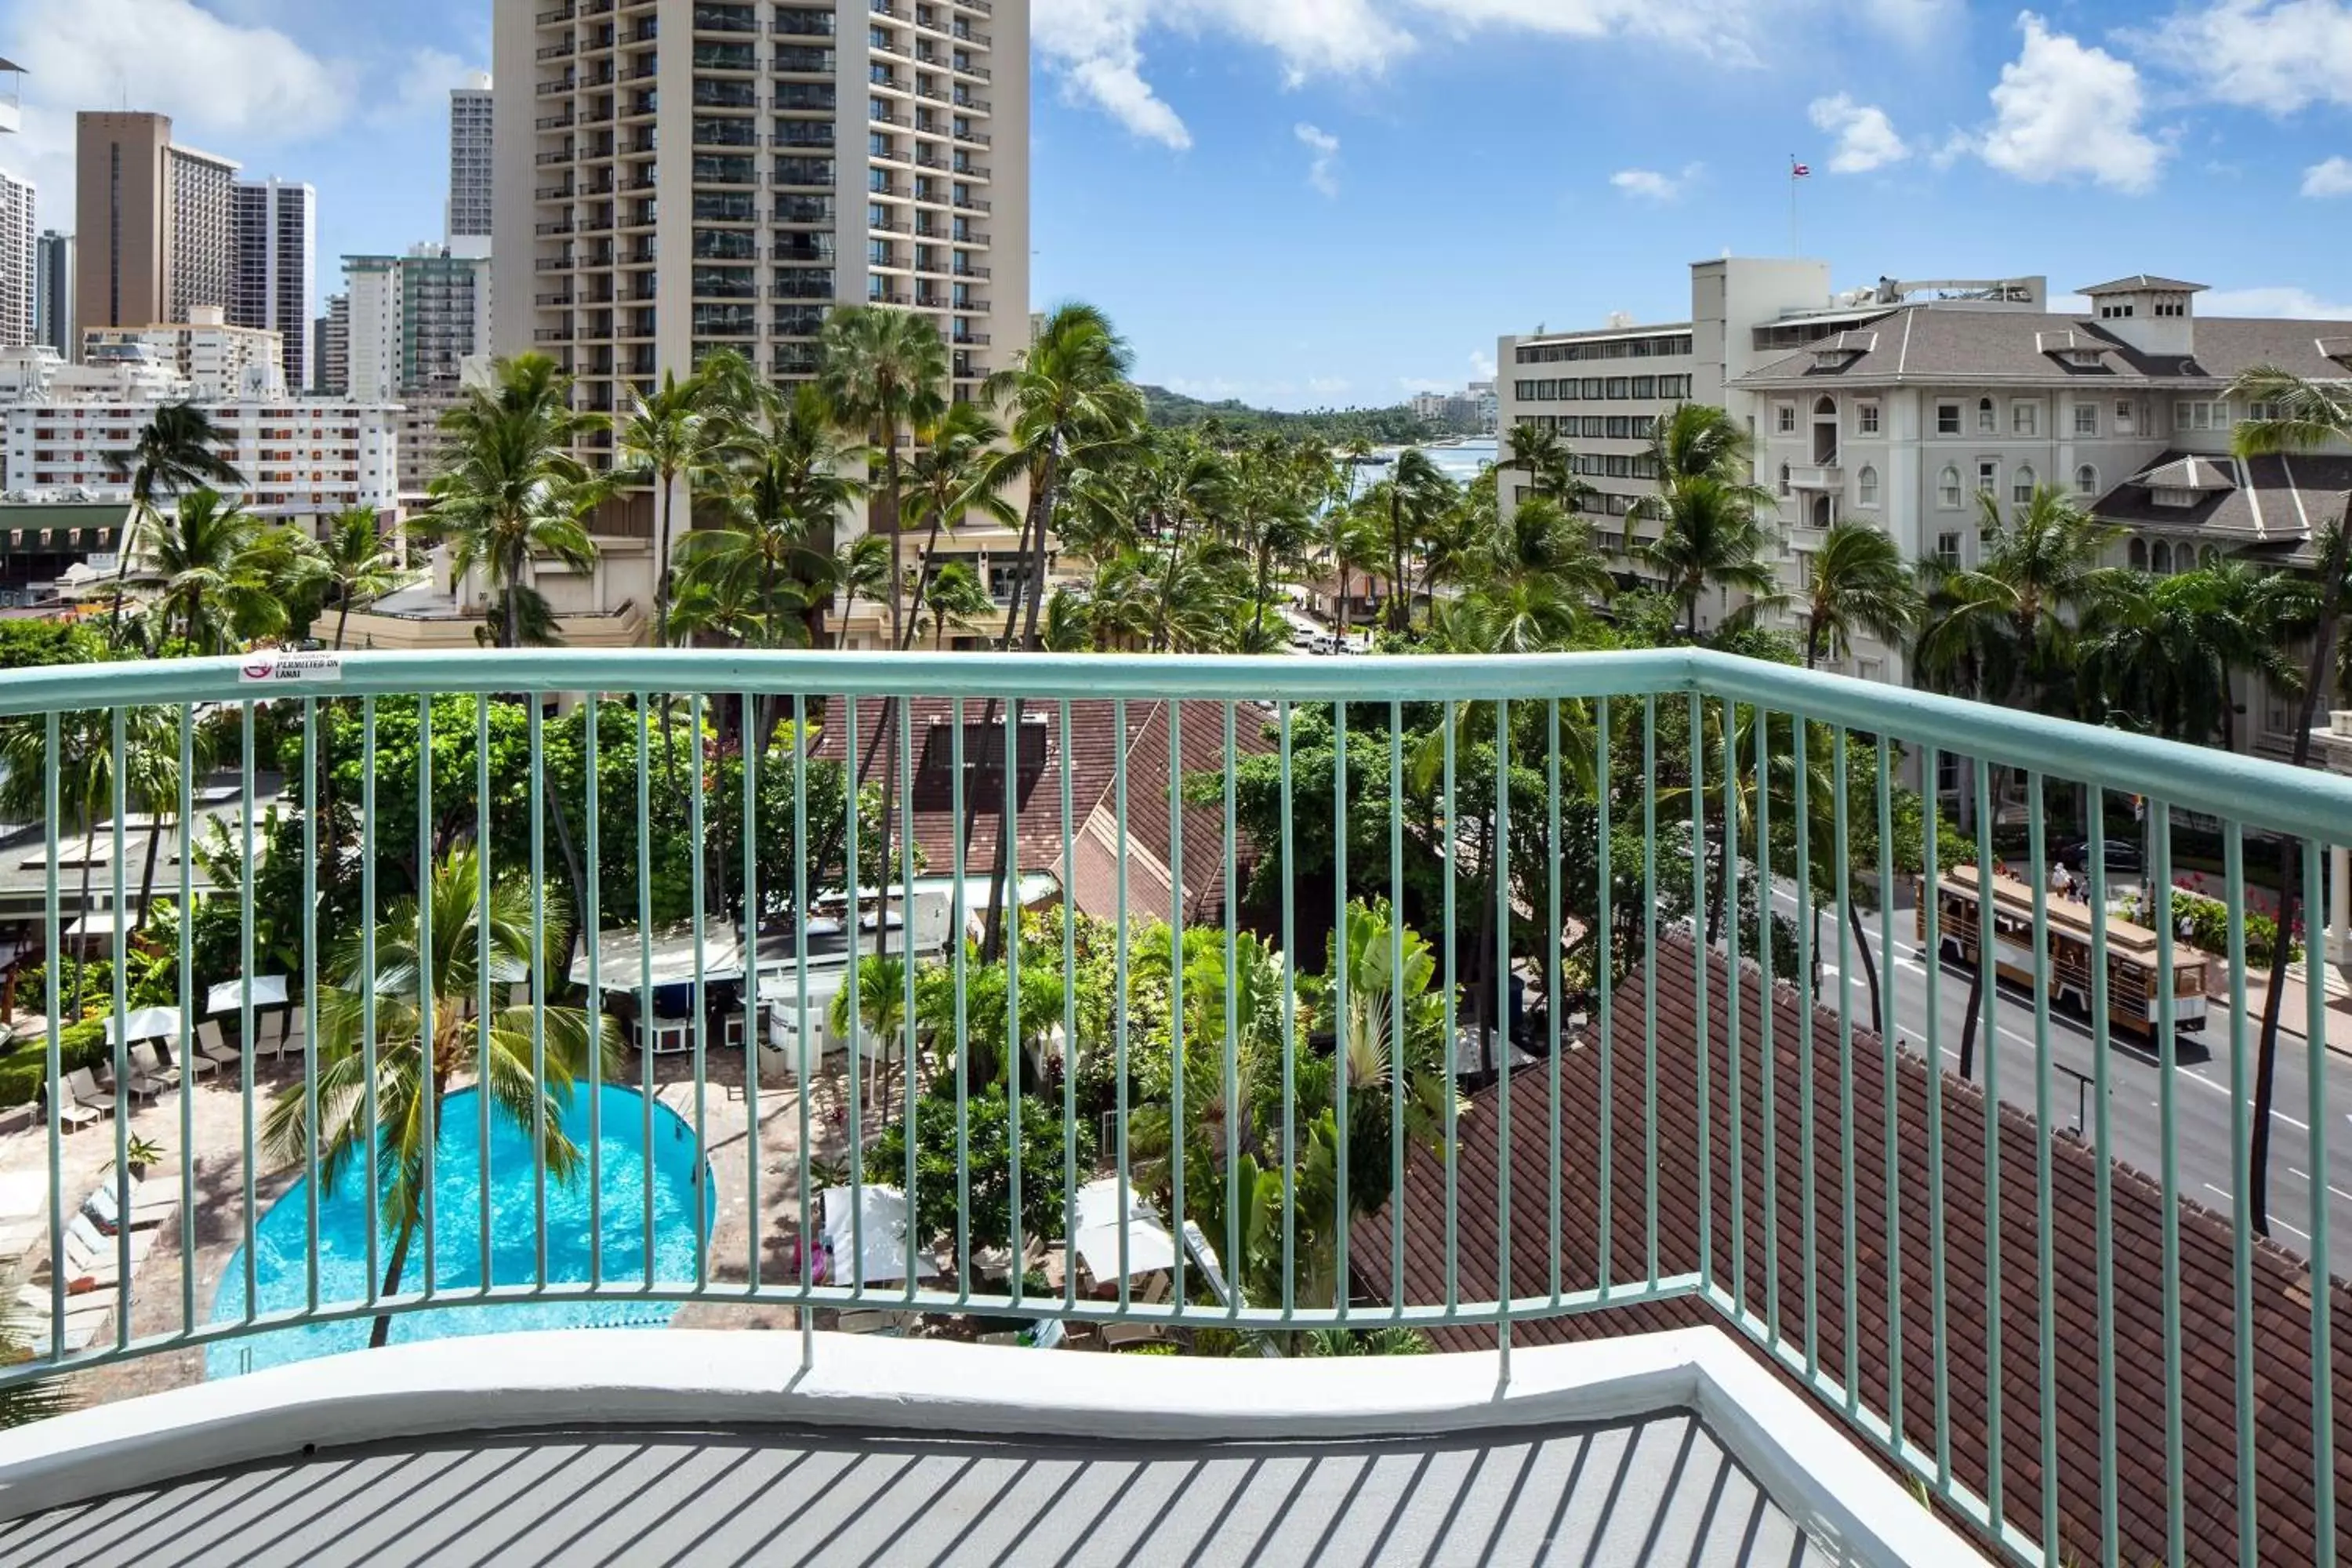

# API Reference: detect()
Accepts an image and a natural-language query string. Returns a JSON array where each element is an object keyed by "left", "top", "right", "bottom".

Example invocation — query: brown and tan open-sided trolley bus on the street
[{"left": 1915, "top": 865, "right": 2206, "bottom": 1039}]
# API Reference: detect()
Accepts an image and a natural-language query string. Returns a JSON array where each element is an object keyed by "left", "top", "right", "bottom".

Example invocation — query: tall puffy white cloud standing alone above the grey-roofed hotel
[{"left": 1978, "top": 12, "right": 2171, "bottom": 191}]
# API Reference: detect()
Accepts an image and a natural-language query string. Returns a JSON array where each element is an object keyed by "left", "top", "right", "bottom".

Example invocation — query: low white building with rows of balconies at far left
[{"left": 0, "top": 385, "right": 400, "bottom": 520}]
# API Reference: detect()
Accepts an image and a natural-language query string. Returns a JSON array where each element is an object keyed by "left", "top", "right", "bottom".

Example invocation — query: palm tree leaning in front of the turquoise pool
[{"left": 261, "top": 844, "right": 619, "bottom": 1347}]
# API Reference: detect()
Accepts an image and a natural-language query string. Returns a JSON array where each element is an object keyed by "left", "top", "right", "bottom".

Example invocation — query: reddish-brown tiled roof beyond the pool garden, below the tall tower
[{"left": 816, "top": 696, "right": 1272, "bottom": 919}]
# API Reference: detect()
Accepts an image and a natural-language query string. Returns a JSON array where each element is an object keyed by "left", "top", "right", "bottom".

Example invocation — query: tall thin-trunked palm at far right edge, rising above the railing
[{"left": 2227, "top": 365, "right": 2352, "bottom": 1236}]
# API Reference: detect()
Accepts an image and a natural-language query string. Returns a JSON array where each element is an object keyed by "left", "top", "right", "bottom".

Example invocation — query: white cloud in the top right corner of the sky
[{"left": 2136, "top": 0, "right": 2352, "bottom": 115}]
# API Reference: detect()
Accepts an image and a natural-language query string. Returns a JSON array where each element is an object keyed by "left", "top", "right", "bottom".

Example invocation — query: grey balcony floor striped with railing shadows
[{"left": 0, "top": 1413, "right": 1830, "bottom": 1568}]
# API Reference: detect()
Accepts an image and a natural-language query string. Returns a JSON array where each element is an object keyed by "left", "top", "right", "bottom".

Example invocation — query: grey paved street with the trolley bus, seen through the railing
[{"left": 1778, "top": 891, "right": 2352, "bottom": 1267}]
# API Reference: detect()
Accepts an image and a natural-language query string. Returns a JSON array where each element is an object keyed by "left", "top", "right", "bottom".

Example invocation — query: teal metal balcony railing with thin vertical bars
[{"left": 0, "top": 652, "right": 2352, "bottom": 1563}]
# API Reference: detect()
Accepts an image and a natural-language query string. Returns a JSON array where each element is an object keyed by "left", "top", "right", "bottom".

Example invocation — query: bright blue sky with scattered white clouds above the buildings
[{"left": 0, "top": 0, "right": 2352, "bottom": 407}]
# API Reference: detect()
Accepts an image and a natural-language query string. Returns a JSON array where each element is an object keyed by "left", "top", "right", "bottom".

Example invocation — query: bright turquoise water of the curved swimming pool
[{"left": 205, "top": 1086, "right": 717, "bottom": 1377}]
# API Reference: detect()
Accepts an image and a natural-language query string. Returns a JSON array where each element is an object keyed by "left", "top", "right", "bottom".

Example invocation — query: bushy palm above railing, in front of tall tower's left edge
[{"left": 426, "top": 355, "right": 609, "bottom": 649}]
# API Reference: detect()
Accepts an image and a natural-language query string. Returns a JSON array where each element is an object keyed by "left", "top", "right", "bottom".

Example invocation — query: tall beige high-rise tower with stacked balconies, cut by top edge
[{"left": 492, "top": 0, "right": 1030, "bottom": 639}]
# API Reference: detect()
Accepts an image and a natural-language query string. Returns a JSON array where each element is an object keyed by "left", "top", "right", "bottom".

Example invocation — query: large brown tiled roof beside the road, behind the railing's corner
[{"left": 1350, "top": 942, "right": 2352, "bottom": 1563}]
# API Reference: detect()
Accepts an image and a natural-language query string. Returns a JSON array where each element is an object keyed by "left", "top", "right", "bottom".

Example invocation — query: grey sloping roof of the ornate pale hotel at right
[{"left": 1736, "top": 306, "right": 2345, "bottom": 393}]
